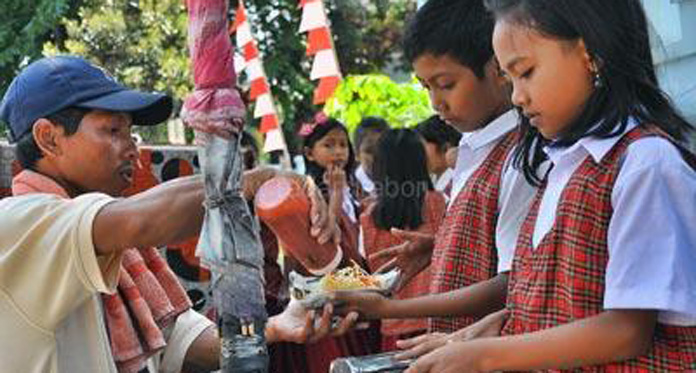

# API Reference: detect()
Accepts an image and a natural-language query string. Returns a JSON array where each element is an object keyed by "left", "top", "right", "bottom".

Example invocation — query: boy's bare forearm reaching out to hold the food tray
[{"left": 335, "top": 273, "right": 508, "bottom": 319}]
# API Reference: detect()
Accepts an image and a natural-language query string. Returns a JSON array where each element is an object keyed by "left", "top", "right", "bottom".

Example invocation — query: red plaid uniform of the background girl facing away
[{"left": 360, "top": 191, "right": 445, "bottom": 336}]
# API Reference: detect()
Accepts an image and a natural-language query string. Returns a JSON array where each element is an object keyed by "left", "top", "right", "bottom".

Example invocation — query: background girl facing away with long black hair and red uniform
[{"left": 360, "top": 129, "right": 445, "bottom": 351}]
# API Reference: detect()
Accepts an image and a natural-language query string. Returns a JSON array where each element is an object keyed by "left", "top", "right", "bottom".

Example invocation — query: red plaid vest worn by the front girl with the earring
[{"left": 502, "top": 127, "right": 696, "bottom": 372}]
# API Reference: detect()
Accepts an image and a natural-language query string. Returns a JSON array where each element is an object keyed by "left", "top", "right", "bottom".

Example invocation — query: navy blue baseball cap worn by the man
[{"left": 0, "top": 56, "right": 172, "bottom": 142}]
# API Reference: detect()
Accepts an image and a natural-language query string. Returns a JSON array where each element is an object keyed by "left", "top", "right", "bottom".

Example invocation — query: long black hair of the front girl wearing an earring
[{"left": 486, "top": 0, "right": 693, "bottom": 185}]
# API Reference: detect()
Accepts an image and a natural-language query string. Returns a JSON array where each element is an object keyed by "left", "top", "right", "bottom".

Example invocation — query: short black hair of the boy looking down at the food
[{"left": 404, "top": 0, "right": 495, "bottom": 78}]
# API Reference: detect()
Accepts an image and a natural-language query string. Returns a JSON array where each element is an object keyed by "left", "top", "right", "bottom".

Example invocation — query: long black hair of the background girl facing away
[{"left": 372, "top": 129, "right": 433, "bottom": 230}]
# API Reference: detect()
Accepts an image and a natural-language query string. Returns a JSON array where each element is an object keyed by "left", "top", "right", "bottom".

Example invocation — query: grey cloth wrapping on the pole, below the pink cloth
[{"left": 198, "top": 136, "right": 268, "bottom": 373}]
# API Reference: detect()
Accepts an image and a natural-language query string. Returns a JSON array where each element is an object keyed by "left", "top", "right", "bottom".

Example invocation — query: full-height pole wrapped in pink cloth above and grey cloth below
[{"left": 181, "top": 0, "right": 268, "bottom": 373}]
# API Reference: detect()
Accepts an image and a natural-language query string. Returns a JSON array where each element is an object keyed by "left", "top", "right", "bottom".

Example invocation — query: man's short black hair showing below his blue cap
[{"left": 15, "top": 107, "right": 90, "bottom": 170}]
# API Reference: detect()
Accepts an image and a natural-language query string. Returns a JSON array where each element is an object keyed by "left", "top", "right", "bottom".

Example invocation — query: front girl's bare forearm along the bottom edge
[{"left": 406, "top": 310, "right": 657, "bottom": 373}]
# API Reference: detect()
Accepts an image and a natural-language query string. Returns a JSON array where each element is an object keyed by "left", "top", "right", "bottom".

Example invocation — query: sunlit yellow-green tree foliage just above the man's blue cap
[{"left": 44, "top": 0, "right": 193, "bottom": 143}]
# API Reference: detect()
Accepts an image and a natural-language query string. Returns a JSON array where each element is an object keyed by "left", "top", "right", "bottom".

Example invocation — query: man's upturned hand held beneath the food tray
[{"left": 266, "top": 299, "right": 358, "bottom": 343}]
